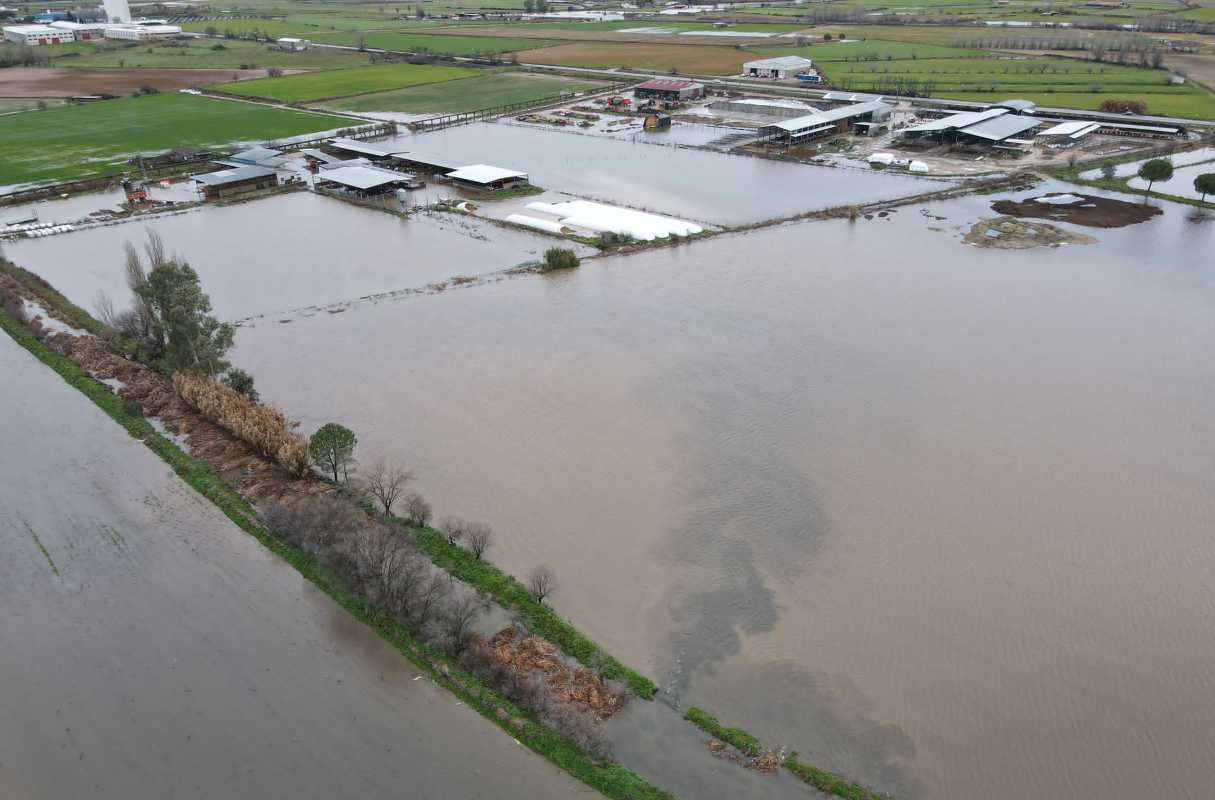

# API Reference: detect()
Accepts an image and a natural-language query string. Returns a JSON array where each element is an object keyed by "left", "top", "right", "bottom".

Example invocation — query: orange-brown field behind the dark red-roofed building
[{"left": 518, "top": 43, "right": 755, "bottom": 75}]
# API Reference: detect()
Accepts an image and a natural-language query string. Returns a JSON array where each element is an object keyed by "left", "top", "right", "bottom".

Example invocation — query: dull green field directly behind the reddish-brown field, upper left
[{"left": 55, "top": 39, "right": 371, "bottom": 69}]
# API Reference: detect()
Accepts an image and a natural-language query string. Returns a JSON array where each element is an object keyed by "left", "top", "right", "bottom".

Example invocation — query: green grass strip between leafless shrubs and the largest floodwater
[{"left": 394, "top": 518, "right": 659, "bottom": 700}]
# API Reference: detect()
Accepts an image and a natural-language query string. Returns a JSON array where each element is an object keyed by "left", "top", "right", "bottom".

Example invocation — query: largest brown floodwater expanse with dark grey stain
[{"left": 225, "top": 183, "right": 1215, "bottom": 800}]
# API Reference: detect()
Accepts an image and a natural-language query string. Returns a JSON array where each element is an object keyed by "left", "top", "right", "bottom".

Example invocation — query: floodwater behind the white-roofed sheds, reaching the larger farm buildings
[{"left": 383, "top": 123, "right": 951, "bottom": 225}]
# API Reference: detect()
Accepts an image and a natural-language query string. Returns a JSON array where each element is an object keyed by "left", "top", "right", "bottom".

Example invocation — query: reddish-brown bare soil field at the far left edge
[{"left": 0, "top": 67, "right": 265, "bottom": 97}]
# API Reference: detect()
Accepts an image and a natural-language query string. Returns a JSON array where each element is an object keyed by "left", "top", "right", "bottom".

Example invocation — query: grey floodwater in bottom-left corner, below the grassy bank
[{"left": 0, "top": 334, "right": 588, "bottom": 800}]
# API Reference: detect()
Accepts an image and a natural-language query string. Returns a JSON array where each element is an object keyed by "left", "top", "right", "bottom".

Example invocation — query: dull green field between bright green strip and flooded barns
[{"left": 324, "top": 73, "right": 608, "bottom": 114}]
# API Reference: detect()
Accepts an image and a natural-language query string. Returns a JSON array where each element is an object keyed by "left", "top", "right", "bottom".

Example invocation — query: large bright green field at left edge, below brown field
[{"left": 0, "top": 92, "right": 349, "bottom": 186}]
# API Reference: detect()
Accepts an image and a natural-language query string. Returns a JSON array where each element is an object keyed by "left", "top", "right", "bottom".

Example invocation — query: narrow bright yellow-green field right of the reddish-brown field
[{"left": 211, "top": 64, "right": 480, "bottom": 103}]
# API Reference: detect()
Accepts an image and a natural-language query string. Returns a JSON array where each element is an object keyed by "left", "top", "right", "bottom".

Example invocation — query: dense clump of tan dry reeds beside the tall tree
[{"left": 173, "top": 372, "right": 311, "bottom": 478}]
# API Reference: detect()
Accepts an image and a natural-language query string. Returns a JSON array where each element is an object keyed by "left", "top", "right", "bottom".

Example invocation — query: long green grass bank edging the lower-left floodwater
[{"left": 0, "top": 261, "right": 673, "bottom": 800}]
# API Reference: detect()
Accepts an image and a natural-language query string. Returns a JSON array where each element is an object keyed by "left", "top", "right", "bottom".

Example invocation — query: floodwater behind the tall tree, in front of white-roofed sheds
[{"left": 6, "top": 192, "right": 589, "bottom": 320}]
